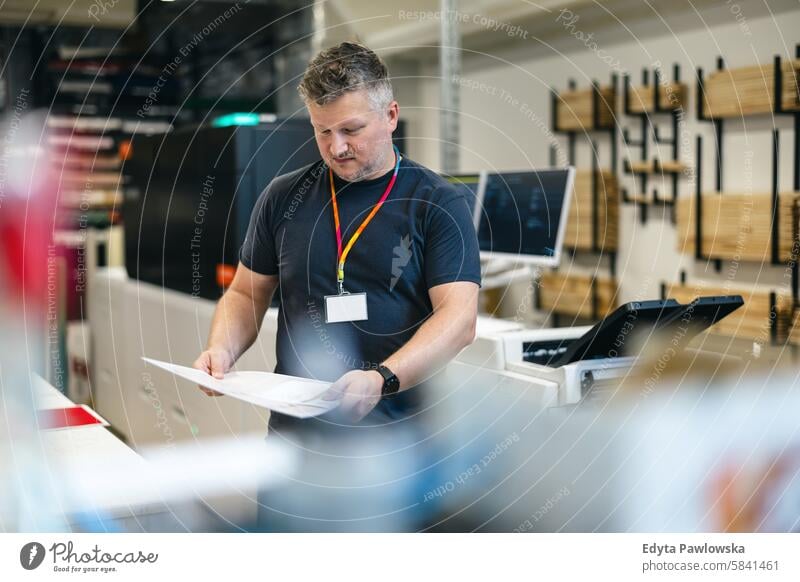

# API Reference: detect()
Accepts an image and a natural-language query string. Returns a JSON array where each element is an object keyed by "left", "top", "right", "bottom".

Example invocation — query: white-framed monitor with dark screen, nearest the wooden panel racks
[{"left": 476, "top": 167, "right": 575, "bottom": 266}]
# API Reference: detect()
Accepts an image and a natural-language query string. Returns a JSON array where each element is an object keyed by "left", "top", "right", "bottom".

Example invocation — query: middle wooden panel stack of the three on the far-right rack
[{"left": 676, "top": 192, "right": 798, "bottom": 262}]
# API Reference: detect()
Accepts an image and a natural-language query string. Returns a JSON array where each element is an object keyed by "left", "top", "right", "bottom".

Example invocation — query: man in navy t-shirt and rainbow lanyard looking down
[{"left": 194, "top": 42, "right": 480, "bottom": 430}]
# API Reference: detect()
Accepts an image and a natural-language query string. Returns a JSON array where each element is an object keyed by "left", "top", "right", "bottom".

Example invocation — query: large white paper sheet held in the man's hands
[{"left": 142, "top": 358, "right": 339, "bottom": 418}]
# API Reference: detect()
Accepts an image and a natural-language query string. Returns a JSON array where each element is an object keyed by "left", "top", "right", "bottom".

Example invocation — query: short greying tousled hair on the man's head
[{"left": 297, "top": 42, "right": 394, "bottom": 111}]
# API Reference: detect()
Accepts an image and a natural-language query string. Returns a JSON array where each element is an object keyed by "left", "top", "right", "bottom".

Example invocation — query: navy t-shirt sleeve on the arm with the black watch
[{"left": 425, "top": 188, "right": 481, "bottom": 289}]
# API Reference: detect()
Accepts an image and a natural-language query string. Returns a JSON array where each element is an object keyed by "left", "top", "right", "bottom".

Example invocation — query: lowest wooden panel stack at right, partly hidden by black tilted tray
[{"left": 667, "top": 283, "right": 792, "bottom": 344}]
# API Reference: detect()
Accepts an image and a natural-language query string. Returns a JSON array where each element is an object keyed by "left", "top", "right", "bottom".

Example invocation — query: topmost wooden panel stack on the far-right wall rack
[{"left": 698, "top": 60, "right": 800, "bottom": 118}]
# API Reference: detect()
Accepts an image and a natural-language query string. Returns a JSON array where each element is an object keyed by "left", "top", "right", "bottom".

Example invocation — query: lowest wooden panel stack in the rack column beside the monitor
[{"left": 538, "top": 272, "right": 617, "bottom": 319}]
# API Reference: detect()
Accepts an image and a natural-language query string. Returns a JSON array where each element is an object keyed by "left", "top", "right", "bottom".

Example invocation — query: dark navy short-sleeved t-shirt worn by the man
[{"left": 234, "top": 157, "right": 480, "bottom": 419}]
